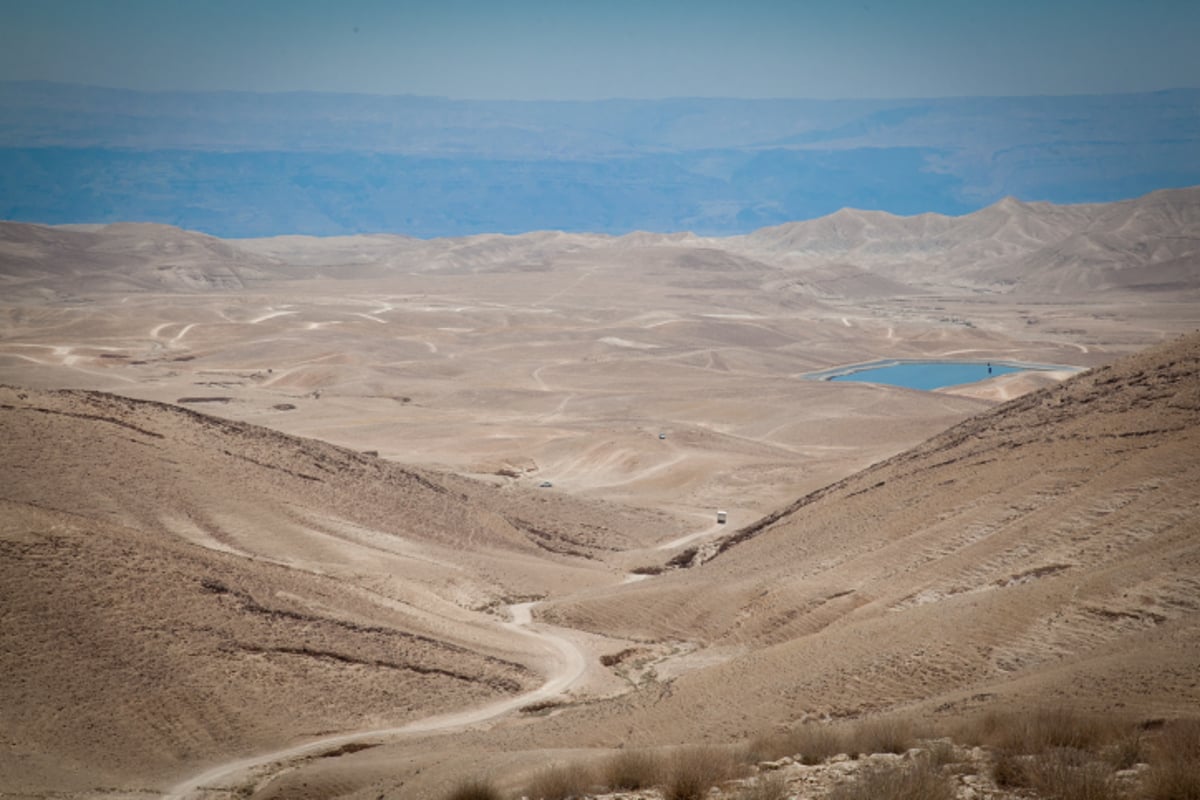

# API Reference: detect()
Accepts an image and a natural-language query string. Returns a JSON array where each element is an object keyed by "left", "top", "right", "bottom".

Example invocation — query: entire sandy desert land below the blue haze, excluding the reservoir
[{"left": 0, "top": 188, "right": 1200, "bottom": 800}]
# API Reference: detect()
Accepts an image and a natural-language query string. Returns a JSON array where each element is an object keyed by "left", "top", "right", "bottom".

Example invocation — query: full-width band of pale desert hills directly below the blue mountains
[{"left": 7, "top": 187, "right": 1200, "bottom": 300}]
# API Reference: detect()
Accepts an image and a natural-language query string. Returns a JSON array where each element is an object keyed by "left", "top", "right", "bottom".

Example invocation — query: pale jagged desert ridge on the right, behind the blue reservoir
[{"left": 731, "top": 187, "right": 1200, "bottom": 294}]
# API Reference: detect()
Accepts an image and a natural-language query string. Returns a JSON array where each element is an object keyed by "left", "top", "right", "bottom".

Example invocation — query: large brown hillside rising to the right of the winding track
[{"left": 551, "top": 336, "right": 1200, "bottom": 735}]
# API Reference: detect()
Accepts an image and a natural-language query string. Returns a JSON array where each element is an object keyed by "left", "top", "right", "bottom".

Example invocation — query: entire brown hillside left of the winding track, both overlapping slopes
[{"left": 0, "top": 387, "right": 686, "bottom": 790}]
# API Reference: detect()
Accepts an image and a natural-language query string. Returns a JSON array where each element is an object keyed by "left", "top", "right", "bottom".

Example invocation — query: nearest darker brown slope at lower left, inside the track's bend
[{"left": 0, "top": 501, "right": 540, "bottom": 790}]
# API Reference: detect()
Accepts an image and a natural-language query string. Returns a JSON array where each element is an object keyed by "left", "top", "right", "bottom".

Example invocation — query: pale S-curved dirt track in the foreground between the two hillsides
[{"left": 163, "top": 603, "right": 587, "bottom": 800}]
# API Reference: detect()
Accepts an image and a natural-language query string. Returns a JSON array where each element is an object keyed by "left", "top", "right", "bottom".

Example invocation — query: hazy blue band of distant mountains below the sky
[{"left": 0, "top": 83, "right": 1200, "bottom": 237}]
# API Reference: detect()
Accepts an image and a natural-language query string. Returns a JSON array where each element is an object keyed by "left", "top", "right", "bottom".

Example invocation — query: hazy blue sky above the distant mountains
[{"left": 0, "top": 0, "right": 1200, "bottom": 100}]
